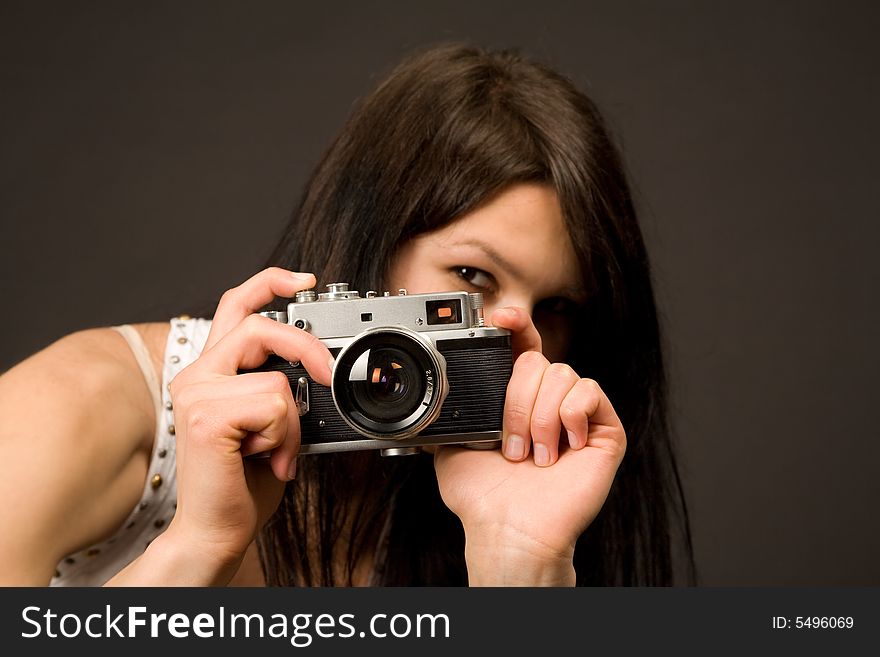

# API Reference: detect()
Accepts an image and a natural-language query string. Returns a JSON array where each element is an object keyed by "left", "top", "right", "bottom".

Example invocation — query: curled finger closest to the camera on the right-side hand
[{"left": 502, "top": 351, "right": 550, "bottom": 461}]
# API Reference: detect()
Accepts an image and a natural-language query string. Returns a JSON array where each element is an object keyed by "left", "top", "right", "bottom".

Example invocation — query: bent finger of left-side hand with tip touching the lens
[{"left": 197, "top": 314, "right": 333, "bottom": 386}]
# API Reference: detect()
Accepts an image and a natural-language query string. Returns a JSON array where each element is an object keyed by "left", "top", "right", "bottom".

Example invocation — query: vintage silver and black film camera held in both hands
[{"left": 255, "top": 283, "right": 513, "bottom": 455}]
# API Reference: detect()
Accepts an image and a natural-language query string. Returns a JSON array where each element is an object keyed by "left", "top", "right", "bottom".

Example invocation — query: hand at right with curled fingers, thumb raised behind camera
[{"left": 434, "top": 308, "right": 626, "bottom": 586}]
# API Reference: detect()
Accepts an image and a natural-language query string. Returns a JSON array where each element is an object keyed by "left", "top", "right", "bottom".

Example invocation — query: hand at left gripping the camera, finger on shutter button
[{"left": 113, "top": 268, "right": 333, "bottom": 583}]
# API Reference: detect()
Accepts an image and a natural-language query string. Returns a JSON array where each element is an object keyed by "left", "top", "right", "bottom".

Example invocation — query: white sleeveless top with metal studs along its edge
[{"left": 50, "top": 317, "right": 211, "bottom": 586}]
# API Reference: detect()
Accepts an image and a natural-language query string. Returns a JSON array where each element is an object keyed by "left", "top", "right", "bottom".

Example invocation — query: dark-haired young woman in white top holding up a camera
[{"left": 0, "top": 46, "right": 692, "bottom": 585}]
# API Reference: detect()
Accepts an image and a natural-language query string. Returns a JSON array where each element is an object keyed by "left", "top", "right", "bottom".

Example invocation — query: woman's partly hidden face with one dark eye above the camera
[{"left": 389, "top": 184, "right": 586, "bottom": 362}]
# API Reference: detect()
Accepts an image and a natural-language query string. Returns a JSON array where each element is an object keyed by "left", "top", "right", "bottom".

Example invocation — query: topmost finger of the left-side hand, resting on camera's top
[{"left": 205, "top": 267, "right": 316, "bottom": 349}]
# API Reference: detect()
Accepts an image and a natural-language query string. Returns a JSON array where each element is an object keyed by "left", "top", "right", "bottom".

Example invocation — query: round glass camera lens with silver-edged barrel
[{"left": 333, "top": 327, "right": 445, "bottom": 438}]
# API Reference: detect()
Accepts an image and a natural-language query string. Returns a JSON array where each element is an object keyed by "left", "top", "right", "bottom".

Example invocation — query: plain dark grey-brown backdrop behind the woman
[{"left": 0, "top": 1, "right": 880, "bottom": 586}]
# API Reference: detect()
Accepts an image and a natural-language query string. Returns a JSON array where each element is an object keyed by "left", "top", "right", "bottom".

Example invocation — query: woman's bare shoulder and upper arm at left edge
[{"left": 0, "top": 324, "right": 168, "bottom": 585}]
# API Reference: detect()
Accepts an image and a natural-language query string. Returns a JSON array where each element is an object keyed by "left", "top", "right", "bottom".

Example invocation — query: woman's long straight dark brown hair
[{"left": 259, "top": 45, "right": 693, "bottom": 585}]
